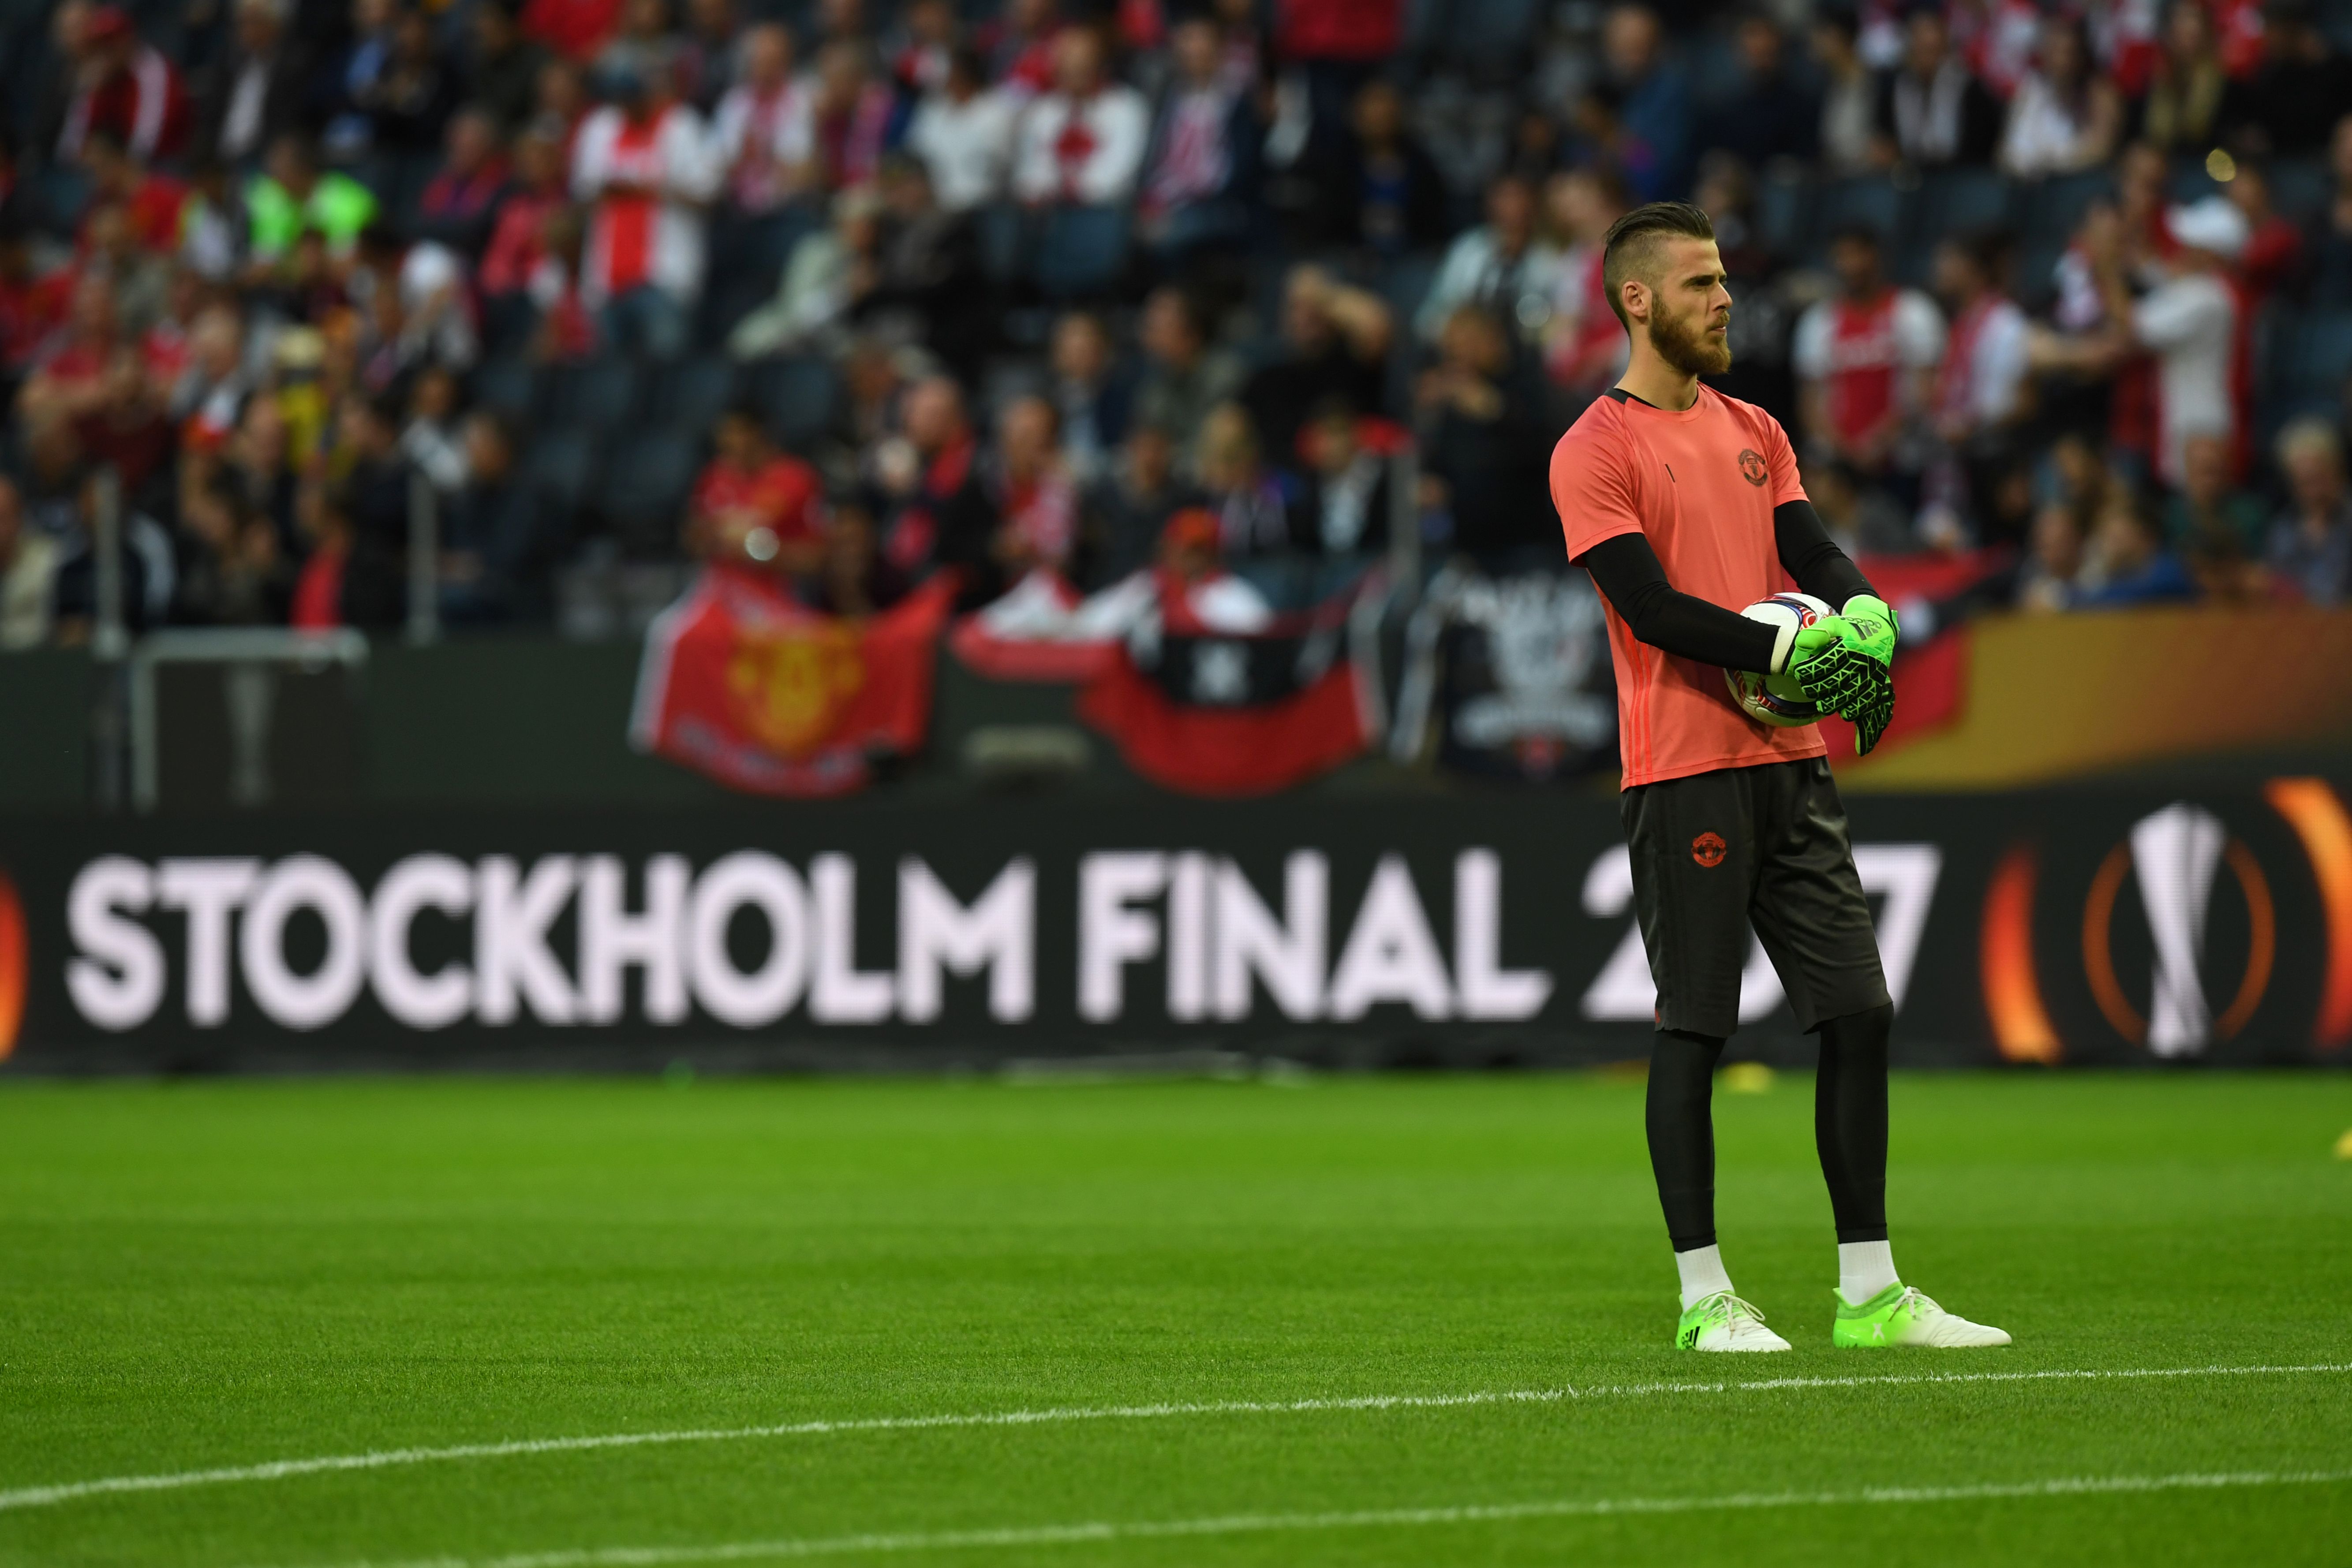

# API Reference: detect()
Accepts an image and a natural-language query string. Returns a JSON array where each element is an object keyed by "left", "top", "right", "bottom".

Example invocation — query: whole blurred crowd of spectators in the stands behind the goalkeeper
[{"left": 0, "top": 0, "right": 2352, "bottom": 646}]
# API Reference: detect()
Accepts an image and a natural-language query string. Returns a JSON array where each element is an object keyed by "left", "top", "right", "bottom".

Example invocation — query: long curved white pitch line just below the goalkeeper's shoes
[{"left": 0, "top": 1361, "right": 2352, "bottom": 1512}]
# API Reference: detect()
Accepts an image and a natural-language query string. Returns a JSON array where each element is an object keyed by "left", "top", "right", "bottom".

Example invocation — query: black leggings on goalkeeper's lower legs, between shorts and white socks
[{"left": 1644, "top": 1006, "right": 1896, "bottom": 1253}]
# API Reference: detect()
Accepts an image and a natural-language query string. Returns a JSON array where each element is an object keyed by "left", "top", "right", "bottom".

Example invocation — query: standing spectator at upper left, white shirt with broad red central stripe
[{"left": 572, "top": 71, "right": 718, "bottom": 360}]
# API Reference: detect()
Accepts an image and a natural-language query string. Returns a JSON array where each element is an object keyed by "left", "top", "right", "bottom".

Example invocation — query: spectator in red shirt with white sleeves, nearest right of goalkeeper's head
[{"left": 1790, "top": 226, "right": 1945, "bottom": 482}]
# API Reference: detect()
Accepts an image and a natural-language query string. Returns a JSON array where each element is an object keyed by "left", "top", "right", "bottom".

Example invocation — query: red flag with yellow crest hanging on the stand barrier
[{"left": 630, "top": 567, "right": 955, "bottom": 795}]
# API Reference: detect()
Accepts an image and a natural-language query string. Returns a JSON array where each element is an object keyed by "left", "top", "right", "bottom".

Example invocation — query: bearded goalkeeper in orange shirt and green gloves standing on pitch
[{"left": 1552, "top": 202, "right": 2008, "bottom": 1349}]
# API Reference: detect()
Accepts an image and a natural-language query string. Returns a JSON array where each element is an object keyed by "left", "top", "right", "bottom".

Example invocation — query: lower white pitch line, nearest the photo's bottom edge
[{"left": 280, "top": 1469, "right": 2352, "bottom": 1568}]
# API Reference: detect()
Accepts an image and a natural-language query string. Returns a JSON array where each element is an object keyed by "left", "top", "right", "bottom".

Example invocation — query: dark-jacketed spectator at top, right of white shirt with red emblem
[{"left": 1138, "top": 16, "right": 1256, "bottom": 263}]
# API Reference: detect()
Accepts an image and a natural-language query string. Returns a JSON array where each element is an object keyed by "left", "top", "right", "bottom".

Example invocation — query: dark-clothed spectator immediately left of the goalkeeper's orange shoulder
[{"left": 1413, "top": 306, "right": 1557, "bottom": 564}]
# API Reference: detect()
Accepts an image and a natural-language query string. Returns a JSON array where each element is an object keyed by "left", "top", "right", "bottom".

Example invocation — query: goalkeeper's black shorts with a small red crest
[{"left": 1620, "top": 757, "right": 1886, "bottom": 1039}]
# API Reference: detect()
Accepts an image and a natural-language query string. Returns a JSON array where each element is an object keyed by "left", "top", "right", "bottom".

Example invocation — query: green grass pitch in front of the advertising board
[{"left": 0, "top": 1074, "right": 2352, "bottom": 1568}]
